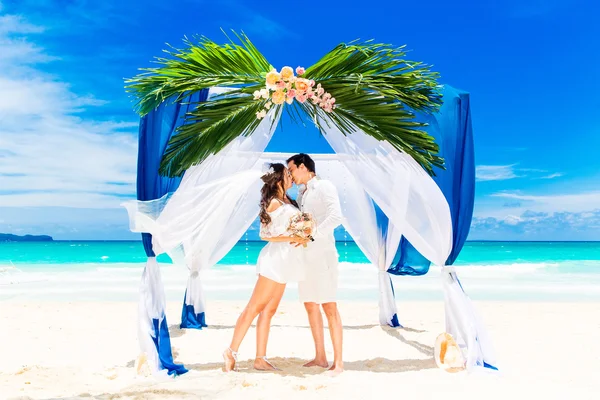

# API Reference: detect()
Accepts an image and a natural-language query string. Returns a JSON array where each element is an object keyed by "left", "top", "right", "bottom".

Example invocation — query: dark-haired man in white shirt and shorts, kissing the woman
[{"left": 287, "top": 153, "right": 344, "bottom": 373}]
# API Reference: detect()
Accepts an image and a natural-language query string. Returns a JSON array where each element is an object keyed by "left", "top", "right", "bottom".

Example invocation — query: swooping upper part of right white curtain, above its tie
[{"left": 321, "top": 115, "right": 452, "bottom": 265}]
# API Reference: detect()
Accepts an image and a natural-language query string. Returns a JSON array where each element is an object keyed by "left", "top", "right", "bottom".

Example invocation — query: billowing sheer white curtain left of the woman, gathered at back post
[{"left": 123, "top": 95, "right": 278, "bottom": 330}]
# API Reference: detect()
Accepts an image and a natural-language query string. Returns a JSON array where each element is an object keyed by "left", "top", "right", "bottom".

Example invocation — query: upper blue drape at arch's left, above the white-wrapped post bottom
[{"left": 137, "top": 89, "right": 208, "bottom": 257}]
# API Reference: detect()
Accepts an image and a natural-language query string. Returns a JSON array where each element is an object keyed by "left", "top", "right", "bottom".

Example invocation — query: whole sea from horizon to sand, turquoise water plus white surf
[{"left": 0, "top": 241, "right": 600, "bottom": 301}]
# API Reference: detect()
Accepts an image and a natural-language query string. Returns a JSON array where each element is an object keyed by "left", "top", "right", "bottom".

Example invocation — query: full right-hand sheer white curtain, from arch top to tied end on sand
[{"left": 320, "top": 120, "right": 495, "bottom": 368}]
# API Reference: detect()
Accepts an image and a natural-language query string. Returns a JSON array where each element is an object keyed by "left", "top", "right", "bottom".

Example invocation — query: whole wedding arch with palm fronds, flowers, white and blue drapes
[{"left": 124, "top": 35, "right": 496, "bottom": 375}]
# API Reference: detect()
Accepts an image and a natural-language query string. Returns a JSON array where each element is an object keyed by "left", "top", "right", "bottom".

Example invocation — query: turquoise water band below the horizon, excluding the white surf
[{"left": 0, "top": 241, "right": 600, "bottom": 272}]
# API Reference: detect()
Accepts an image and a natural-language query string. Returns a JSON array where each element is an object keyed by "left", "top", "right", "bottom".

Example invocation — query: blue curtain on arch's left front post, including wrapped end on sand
[{"left": 137, "top": 89, "right": 208, "bottom": 375}]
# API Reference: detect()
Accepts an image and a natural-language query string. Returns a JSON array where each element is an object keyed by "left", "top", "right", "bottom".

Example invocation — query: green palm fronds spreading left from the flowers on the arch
[{"left": 126, "top": 34, "right": 280, "bottom": 176}]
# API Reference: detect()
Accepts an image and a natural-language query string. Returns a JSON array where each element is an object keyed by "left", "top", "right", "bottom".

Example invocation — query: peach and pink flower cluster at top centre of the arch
[{"left": 254, "top": 67, "right": 336, "bottom": 119}]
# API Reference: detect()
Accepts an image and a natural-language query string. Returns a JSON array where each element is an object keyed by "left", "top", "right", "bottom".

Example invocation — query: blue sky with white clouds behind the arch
[{"left": 0, "top": 0, "right": 600, "bottom": 240}]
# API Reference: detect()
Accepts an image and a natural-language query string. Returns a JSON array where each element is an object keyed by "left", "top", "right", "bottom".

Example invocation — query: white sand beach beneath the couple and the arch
[{"left": 0, "top": 301, "right": 600, "bottom": 400}]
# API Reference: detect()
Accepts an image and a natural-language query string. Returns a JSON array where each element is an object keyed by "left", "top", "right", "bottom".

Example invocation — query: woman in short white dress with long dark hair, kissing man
[{"left": 223, "top": 163, "right": 307, "bottom": 372}]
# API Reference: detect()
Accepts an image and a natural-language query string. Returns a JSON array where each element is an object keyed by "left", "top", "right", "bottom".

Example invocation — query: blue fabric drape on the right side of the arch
[{"left": 388, "top": 85, "right": 475, "bottom": 275}]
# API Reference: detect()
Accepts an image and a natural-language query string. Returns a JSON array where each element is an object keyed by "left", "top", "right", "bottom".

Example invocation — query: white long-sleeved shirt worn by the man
[{"left": 298, "top": 176, "right": 343, "bottom": 250}]
